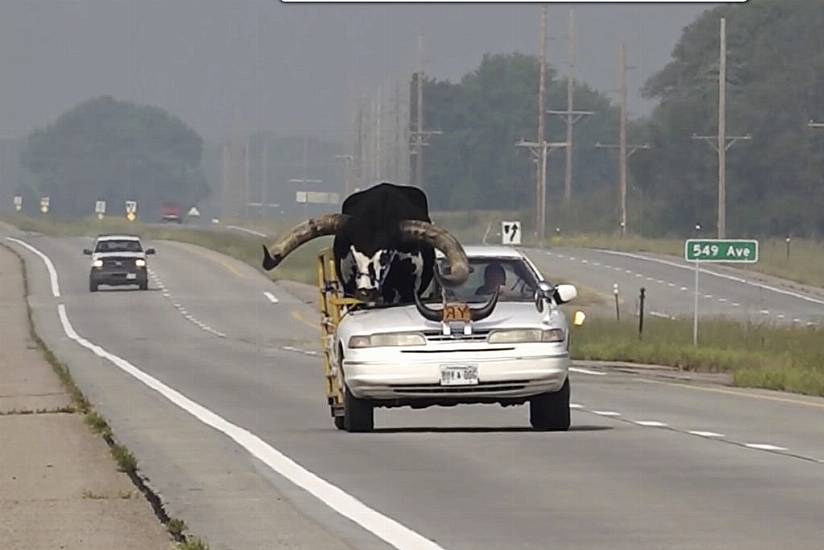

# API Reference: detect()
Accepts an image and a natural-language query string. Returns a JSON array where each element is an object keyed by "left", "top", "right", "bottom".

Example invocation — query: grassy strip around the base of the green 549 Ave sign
[{"left": 571, "top": 318, "right": 824, "bottom": 397}]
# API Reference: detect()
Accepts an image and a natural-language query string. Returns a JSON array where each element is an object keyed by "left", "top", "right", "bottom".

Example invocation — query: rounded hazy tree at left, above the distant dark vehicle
[{"left": 21, "top": 96, "right": 209, "bottom": 217}]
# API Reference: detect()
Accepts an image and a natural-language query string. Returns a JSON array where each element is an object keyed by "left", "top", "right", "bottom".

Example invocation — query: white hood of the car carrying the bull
[{"left": 340, "top": 302, "right": 565, "bottom": 334}]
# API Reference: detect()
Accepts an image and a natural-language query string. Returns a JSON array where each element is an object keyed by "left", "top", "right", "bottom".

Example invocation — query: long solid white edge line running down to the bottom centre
[{"left": 58, "top": 304, "right": 443, "bottom": 550}]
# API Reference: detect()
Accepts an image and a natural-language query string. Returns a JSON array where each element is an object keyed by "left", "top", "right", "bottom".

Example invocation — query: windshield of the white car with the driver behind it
[{"left": 424, "top": 258, "right": 538, "bottom": 303}]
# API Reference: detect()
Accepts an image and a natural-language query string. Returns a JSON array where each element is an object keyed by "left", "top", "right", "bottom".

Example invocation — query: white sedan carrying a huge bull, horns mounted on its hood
[{"left": 332, "top": 246, "right": 577, "bottom": 431}]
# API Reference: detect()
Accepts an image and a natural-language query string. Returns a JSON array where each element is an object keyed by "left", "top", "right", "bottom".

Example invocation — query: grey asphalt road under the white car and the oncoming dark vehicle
[{"left": 0, "top": 230, "right": 824, "bottom": 550}]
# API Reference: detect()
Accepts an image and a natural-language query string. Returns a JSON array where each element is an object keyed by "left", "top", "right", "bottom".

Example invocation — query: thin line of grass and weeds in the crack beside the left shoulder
[{"left": 0, "top": 243, "right": 209, "bottom": 550}]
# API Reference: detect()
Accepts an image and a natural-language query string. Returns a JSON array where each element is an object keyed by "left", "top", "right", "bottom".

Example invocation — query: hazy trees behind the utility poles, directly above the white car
[{"left": 424, "top": 53, "right": 617, "bottom": 230}]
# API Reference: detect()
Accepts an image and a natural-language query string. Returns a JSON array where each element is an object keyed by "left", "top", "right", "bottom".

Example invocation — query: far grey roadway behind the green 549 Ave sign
[{"left": 529, "top": 249, "right": 824, "bottom": 326}]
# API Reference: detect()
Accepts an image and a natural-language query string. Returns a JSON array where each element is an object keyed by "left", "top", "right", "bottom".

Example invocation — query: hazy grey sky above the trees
[{"left": 0, "top": 0, "right": 707, "bottom": 140}]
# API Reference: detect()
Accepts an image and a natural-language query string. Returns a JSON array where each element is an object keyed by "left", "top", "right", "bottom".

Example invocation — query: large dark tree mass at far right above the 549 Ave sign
[{"left": 634, "top": 0, "right": 824, "bottom": 235}]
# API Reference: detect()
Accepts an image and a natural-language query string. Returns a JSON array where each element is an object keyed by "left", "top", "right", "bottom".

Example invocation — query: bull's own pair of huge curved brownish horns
[{"left": 263, "top": 214, "right": 469, "bottom": 286}]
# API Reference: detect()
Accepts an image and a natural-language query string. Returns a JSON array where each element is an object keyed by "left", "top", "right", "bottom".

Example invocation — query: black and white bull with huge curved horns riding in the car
[{"left": 263, "top": 183, "right": 469, "bottom": 305}]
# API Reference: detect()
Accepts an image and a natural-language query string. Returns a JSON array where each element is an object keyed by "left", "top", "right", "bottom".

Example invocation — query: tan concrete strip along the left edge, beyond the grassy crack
[{"left": 0, "top": 247, "right": 172, "bottom": 550}]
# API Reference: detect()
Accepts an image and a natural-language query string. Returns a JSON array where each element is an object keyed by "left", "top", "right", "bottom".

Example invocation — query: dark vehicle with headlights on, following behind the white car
[{"left": 83, "top": 235, "right": 155, "bottom": 292}]
